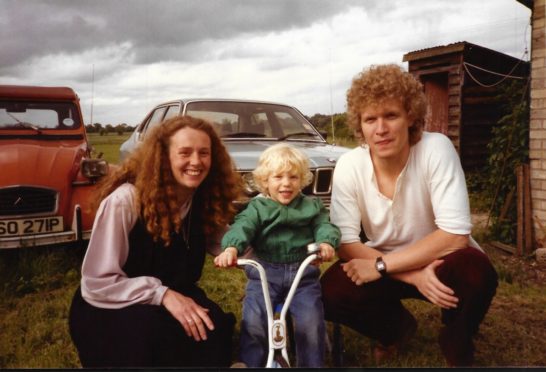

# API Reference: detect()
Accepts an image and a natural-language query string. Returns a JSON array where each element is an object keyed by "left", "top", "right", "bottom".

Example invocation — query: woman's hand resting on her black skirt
[{"left": 161, "top": 289, "right": 214, "bottom": 341}]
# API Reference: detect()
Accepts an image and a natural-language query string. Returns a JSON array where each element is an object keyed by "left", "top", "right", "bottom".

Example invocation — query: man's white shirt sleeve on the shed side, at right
[{"left": 427, "top": 135, "right": 472, "bottom": 235}]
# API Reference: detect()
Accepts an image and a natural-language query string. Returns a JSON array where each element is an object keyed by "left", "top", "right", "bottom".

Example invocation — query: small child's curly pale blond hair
[{"left": 252, "top": 143, "right": 313, "bottom": 194}]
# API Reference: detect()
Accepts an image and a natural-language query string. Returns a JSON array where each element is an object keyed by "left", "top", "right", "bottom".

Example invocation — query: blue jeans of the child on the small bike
[{"left": 240, "top": 260, "right": 326, "bottom": 368}]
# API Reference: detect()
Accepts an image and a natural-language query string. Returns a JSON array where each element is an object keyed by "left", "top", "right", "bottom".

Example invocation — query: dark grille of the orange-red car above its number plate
[{"left": 0, "top": 186, "right": 59, "bottom": 217}]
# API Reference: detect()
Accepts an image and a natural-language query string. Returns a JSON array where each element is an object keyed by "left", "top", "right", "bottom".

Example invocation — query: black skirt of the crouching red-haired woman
[{"left": 69, "top": 286, "right": 235, "bottom": 368}]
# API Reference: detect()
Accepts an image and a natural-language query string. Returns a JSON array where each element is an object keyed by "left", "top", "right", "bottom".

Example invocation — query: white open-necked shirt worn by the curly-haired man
[{"left": 330, "top": 132, "right": 481, "bottom": 252}]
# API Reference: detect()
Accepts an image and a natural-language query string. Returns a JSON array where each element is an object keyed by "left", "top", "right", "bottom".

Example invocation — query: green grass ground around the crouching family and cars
[{"left": 0, "top": 134, "right": 546, "bottom": 369}]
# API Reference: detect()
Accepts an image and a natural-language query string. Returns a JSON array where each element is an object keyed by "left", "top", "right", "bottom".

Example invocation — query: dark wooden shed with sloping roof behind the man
[{"left": 403, "top": 41, "right": 529, "bottom": 171}]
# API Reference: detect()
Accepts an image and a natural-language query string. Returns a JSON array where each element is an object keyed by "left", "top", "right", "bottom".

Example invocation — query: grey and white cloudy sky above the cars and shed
[{"left": 0, "top": 0, "right": 531, "bottom": 125}]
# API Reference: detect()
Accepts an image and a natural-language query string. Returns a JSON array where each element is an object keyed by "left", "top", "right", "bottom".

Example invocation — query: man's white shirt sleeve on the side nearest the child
[{"left": 330, "top": 156, "right": 362, "bottom": 244}]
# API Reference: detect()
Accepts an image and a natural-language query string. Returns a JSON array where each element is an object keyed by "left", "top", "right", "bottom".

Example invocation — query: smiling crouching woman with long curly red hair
[{"left": 69, "top": 116, "right": 240, "bottom": 367}]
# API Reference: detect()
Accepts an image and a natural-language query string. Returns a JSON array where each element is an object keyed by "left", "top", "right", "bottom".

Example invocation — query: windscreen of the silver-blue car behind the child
[{"left": 184, "top": 101, "right": 323, "bottom": 142}]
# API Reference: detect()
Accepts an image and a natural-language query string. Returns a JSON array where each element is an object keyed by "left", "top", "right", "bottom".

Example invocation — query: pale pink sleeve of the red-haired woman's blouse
[{"left": 81, "top": 184, "right": 167, "bottom": 309}]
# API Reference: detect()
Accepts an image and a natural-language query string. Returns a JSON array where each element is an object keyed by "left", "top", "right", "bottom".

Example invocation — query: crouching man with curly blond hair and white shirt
[{"left": 322, "top": 65, "right": 497, "bottom": 366}]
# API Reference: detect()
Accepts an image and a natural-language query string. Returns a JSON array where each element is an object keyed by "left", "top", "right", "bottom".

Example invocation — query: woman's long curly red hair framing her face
[{"left": 93, "top": 116, "right": 241, "bottom": 245}]
